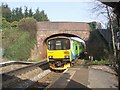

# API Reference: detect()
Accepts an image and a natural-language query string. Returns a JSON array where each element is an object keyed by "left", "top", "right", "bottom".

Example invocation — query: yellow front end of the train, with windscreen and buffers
[{"left": 47, "top": 38, "right": 71, "bottom": 70}]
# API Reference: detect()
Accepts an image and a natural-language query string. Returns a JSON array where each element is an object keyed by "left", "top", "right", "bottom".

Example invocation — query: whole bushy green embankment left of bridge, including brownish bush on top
[{"left": 3, "top": 17, "right": 36, "bottom": 61}]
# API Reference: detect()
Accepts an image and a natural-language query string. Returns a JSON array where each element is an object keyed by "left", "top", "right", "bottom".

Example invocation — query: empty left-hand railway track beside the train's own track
[{"left": 0, "top": 61, "right": 49, "bottom": 88}]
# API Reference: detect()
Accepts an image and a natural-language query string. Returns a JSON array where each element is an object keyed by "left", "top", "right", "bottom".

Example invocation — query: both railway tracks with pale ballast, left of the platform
[{"left": 1, "top": 58, "right": 83, "bottom": 89}]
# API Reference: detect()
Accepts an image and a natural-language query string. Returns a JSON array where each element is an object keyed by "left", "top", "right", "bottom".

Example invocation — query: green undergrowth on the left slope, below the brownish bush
[{"left": 2, "top": 28, "right": 35, "bottom": 61}]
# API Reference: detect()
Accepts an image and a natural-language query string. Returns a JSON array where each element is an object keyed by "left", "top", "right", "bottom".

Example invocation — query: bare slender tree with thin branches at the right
[{"left": 93, "top": 2, "right": 116, "bottom": 66}]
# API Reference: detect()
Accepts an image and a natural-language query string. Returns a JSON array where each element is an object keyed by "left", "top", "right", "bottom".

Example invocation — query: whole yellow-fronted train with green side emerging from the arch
[{"left": 46, "top": 36, "right": 86, "bottom": 70}]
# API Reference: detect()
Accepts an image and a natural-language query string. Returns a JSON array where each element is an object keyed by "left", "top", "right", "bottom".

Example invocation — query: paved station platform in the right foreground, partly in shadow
[{"left": 47, "top": 67, "right": 118, "bottom": 90}]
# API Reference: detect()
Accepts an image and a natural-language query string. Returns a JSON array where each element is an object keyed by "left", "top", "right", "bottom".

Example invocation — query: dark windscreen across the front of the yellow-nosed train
[{"left": 48, "top": 38, "right": 70, "bottom": 50}]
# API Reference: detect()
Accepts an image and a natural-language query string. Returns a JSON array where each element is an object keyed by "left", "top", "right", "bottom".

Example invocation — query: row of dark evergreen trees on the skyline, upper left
[{"left": 0, "top": 3, "right": 49, "bottom": 22}]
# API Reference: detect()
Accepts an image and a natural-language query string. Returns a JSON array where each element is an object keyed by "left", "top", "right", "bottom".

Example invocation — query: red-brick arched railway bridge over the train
[{"left": 31, "top": 21, "right": 90, "bottom": 59}]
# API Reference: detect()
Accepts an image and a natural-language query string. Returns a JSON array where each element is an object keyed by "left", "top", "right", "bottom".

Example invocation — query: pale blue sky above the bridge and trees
[{"left": 1, "top": 0, "right": 107, "bottom": 27}]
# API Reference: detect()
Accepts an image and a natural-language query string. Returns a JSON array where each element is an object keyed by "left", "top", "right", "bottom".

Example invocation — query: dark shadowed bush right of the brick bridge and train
[{"left": 86, "top": 30, "right": 109, "bottom": 60}]
